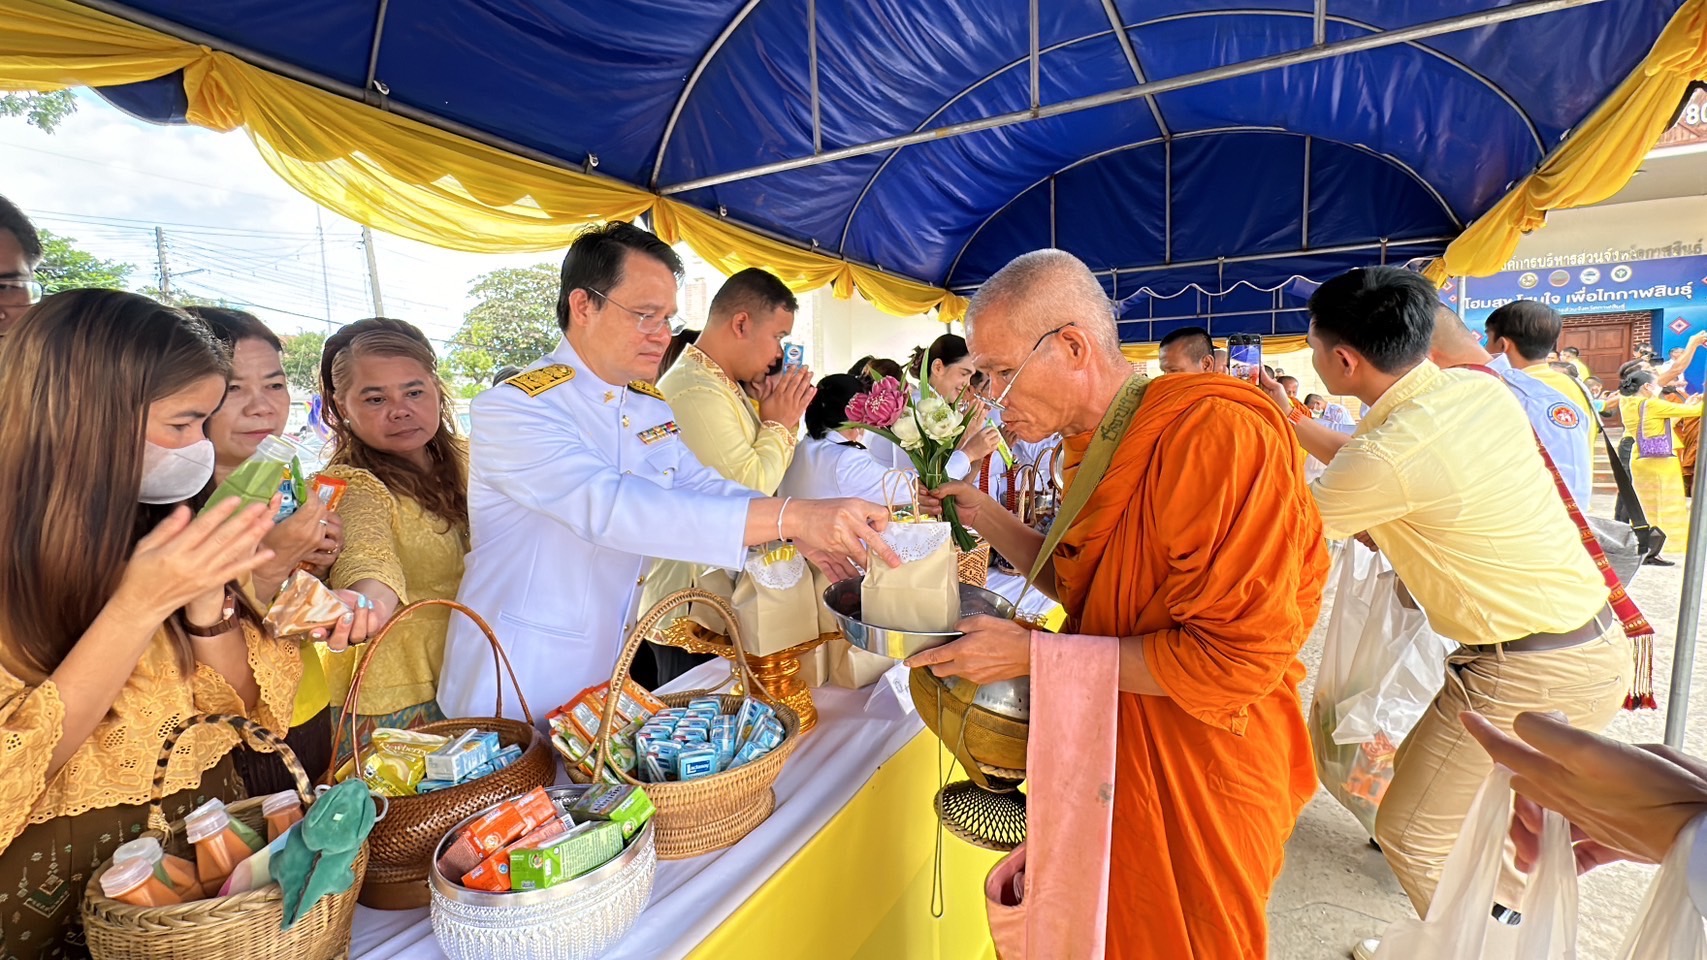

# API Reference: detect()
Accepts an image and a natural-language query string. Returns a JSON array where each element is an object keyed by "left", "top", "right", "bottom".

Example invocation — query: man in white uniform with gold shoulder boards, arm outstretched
[{"left": 439, "top": 222, "right": 898, "bottom": 724}]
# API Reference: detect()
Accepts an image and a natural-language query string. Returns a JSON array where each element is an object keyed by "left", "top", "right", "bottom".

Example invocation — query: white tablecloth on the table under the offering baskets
[{"left": 350, "top": 661, "right": 923, "bottom": 960}]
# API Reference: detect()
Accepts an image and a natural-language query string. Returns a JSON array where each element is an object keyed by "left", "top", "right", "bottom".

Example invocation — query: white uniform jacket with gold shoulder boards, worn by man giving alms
[{"left": 439, "top": 340, "right": 760, "bottom": 728}]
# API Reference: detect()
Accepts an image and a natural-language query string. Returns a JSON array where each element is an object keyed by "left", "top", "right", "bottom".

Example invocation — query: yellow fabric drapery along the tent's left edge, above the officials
[{"left": 0, "top": 0, "right": 966, "bottom": 323}]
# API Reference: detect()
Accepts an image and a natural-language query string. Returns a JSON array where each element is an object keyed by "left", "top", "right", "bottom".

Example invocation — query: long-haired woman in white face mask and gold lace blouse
[{"left": 0, "top": 290, "right": 302, "bottom": 958}]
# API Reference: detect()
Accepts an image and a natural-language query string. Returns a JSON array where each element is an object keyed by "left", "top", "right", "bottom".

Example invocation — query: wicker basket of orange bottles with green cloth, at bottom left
[{"left": 82, "top": 714, "right": 372, "bottom": 960}]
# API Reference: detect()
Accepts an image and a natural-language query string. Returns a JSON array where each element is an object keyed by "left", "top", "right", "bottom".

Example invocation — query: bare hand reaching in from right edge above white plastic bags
[{"left": 1459, "top": 711, "right": 1707, "bottom": 868}]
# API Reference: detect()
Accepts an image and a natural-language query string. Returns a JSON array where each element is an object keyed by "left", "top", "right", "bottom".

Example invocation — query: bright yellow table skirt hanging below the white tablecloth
[{"left": 690, "top": 731, "right": 1000, "bottom": 960}]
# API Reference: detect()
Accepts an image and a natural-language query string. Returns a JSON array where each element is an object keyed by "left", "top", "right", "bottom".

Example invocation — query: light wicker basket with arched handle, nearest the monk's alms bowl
[{"left": 592, "top": 589, "right": 801, "bottom": 859}]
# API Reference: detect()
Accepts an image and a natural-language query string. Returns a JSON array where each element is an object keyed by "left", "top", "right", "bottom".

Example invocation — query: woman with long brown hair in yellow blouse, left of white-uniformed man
[{"left": 321, "top": 318, "right": 468, "bottom": 740}]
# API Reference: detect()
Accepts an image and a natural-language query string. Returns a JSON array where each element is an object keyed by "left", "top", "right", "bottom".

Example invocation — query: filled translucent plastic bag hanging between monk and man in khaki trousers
[{"left": 1309, "top": 543, "right": 1454, "bottom": 837}]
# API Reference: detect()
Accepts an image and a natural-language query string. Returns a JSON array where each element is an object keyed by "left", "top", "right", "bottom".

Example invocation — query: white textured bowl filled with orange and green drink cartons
[{"left": 432, "top": 784, "right": 657, "bottom": 960}]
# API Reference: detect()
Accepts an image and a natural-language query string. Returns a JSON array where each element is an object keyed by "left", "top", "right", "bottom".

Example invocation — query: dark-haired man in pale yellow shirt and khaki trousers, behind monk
[{"left": 1267, "top": 266, "right": 1634, "bottom": 958}]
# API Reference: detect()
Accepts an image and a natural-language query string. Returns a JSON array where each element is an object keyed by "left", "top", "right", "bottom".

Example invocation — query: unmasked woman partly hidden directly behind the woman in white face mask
[{"left": 184, "top": 307, "right": 348, "bottom": 796}]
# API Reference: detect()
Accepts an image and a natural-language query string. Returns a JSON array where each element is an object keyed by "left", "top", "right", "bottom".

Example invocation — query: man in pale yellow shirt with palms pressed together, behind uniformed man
[{"left": 640, "top": 266, "right": 814, "bottom": 683}]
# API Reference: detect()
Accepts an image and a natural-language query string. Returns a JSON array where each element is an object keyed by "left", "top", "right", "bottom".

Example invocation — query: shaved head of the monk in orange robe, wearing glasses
[{"left": 966, "top": 249, "right": 1132, "bottom": 442}]
